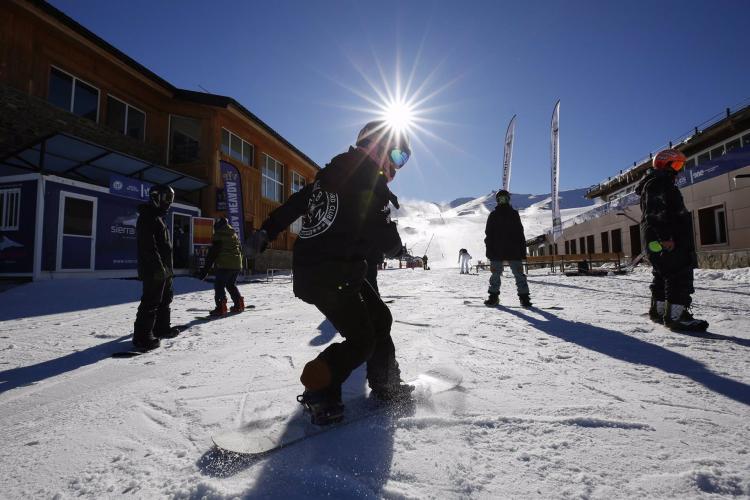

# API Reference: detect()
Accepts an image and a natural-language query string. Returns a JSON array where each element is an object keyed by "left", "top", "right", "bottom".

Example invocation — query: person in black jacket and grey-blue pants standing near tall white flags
[{"left": 484, "top": 189, "right": 531, "bottom": 307}]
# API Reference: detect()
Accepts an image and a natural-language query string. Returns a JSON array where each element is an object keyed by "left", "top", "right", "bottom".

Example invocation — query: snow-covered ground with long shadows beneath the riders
[{"left": 0, "top": 268, "right": 750, "bottom": 499}]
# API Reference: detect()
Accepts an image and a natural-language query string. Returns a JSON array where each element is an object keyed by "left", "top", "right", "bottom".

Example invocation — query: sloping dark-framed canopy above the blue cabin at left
[{"left": 0, "top": 134, "right": 208, "bottom": 192}]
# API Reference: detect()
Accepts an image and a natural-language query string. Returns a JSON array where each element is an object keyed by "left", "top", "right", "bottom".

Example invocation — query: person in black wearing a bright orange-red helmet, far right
[{"left": 636, "top": 149, "right": 708, "bottom": 331}]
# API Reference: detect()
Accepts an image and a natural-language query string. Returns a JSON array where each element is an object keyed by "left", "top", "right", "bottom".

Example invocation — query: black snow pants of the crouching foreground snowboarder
[{"left": 294, "top": 261, "right": 401, "bottom": 392}]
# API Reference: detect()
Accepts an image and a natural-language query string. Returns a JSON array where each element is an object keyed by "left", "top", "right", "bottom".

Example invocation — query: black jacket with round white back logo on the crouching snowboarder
[{"left": 262, "top": 148, "right": 401, "bottom": 269}]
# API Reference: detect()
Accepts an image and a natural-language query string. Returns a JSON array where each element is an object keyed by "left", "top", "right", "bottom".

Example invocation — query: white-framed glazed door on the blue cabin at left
[{"left": 56, "top": 191, "right": 97, "bottom": 271}]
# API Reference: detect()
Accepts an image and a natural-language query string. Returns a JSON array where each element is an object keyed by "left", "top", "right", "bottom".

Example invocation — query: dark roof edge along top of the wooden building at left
[{"left": 24, "top": 0, "right": 320, "bottom": 169}]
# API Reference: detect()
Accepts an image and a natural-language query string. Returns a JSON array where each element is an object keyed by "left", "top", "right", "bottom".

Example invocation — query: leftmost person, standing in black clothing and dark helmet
[{"left": 133, "top": 185, "right": 179, "bottom": 352}]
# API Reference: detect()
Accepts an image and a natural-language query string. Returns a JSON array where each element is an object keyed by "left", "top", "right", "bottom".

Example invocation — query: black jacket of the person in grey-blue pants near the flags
[{"left": 484, "top": 205, "right": 526, "bottom": 260}]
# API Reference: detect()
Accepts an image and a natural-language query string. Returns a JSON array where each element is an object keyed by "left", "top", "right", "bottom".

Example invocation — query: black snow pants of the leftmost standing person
[{"left": 133, "top": 278, "right": 174, "bottom": 342}]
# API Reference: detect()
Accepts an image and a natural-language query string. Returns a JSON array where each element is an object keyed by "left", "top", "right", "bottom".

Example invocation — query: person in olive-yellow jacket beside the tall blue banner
[{"left": 198, "top": 217, "right": 245, "bottom": 317}]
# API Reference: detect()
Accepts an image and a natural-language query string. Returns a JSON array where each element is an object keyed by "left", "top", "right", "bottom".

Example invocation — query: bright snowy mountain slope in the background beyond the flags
[{"left": 392, "top": 193, "right": 591, "bottom": 268}]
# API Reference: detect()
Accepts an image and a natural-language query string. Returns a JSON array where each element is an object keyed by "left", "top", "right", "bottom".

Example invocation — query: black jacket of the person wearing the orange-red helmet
[{"left": 635, "top": 170, "right": 695, "bottom": 252}]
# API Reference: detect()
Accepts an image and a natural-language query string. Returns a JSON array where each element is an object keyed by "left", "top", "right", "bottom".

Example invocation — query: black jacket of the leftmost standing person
[{"left": 135, "top": 203, "right": 174, "bottom": 280}]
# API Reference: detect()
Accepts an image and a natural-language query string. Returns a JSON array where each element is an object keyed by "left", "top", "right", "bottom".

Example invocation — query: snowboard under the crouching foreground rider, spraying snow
[{"left": 211, "top": 369, "right": 463, "bottom": 456}]
